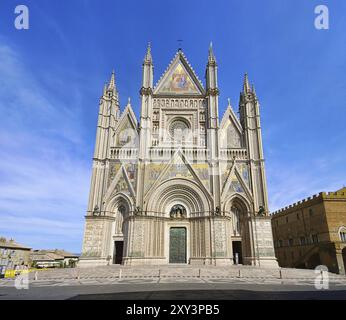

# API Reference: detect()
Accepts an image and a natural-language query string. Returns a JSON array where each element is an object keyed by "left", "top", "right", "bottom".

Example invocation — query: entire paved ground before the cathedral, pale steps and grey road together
[{"left": 0, "top": 266, "right": 346, "bottom": 300}]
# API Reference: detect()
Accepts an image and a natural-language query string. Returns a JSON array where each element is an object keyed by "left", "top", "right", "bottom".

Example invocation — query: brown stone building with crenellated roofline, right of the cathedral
[{"left": 272, "top": 188, "right": 346, "bottom": 274}]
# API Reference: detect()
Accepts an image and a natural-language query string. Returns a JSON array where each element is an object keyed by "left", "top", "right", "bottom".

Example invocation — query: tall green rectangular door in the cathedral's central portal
[{"left": 169, "top": 228, "right": 186, "bottom": 263}]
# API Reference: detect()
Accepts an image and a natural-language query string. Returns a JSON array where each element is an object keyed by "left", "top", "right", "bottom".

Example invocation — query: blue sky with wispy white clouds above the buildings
[{"left": 0, "top": 0, "right": 346, "bottom": 252}]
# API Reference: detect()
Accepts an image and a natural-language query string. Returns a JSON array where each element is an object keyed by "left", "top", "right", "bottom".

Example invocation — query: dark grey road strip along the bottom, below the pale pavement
[{"left": 0, "top": 283, "right": 346, "bottom": 300}]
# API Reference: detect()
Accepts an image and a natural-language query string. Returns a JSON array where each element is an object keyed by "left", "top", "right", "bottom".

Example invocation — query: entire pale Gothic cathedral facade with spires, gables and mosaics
[{"left": 79, "top": 45, "right": 277, "bottom": 267}]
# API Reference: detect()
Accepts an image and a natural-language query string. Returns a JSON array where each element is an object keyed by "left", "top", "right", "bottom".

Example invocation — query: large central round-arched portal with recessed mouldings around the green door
[{"left": 145, "top": 178, "right": 211, "bottom": 264}]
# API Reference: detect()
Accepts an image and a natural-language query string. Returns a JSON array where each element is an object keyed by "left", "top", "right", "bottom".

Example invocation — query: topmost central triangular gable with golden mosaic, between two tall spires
[{"left": 154, "top": 51, "right": 204, "bottom": 95}]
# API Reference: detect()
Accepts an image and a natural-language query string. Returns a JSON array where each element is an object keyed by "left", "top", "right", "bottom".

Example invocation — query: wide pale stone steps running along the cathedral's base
[{"left": 23, "top": 265, "right": 346, "bottom": 283}]
